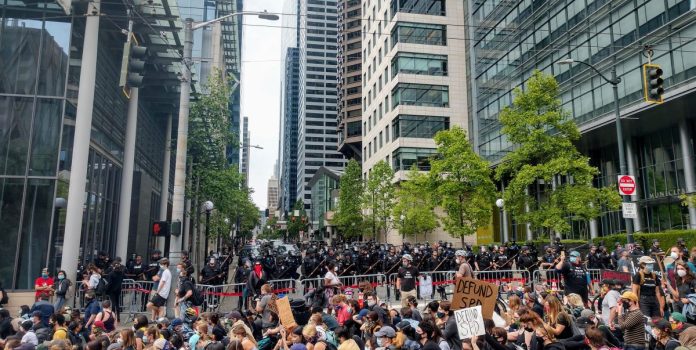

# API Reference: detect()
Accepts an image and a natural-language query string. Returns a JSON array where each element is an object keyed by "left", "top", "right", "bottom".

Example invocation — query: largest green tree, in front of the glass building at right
[{"left": 496, "top": 71, "right": 621, "bottom": 234}]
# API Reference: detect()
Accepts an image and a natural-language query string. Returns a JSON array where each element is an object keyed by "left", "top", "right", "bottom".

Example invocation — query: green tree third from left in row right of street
[{"left": 392, "top": 165, "right": 439, "bottom": 240}]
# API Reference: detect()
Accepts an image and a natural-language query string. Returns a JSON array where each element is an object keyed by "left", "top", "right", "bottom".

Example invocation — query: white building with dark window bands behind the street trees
[{"left": 362, "top": 0, "right": 469, "bottom": 179}]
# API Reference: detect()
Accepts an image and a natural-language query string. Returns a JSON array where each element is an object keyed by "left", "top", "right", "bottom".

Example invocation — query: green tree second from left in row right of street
[{"left": 363, "top": 160, "right": 394, "bottom": 240}]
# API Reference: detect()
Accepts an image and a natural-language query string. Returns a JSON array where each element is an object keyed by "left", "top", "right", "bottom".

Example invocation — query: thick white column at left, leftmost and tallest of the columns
[{"left": 60, "top": 0, "right": 100, "bottom": 281}]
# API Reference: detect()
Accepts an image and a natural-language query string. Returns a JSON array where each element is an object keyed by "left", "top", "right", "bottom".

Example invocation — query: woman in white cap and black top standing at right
[{"left": 631, "top": 256, "right": 665, "bottom": 318}]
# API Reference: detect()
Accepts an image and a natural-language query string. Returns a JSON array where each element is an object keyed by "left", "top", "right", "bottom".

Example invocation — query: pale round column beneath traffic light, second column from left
[{"left": 116, "top": 88, "right": 139, "bottom": 259}]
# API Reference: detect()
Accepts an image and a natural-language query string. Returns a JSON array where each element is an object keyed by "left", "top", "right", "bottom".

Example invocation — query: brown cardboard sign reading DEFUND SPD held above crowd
[{"left": 452, "top": 277, "right": 498, "bottom": 319}]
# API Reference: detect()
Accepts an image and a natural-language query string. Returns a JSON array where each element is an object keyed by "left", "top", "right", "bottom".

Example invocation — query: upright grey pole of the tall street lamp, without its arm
[{"left": 169, "top": 18, "right": 193, "bottom": 265}]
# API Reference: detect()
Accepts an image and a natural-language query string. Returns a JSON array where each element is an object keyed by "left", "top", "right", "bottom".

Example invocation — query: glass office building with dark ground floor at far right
[{"left": 467, "top": 0, "right": 696, "bottom": 238}]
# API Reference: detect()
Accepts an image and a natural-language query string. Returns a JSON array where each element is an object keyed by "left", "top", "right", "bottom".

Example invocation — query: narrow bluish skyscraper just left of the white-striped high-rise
[{"left": 278, "top": 0, "right": 300, "bottom": 211}]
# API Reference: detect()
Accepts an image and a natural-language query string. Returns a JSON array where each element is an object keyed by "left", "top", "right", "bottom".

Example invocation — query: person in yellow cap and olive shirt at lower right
[{"left": 617, "top": 291, "right": 645, "bottom": 350}]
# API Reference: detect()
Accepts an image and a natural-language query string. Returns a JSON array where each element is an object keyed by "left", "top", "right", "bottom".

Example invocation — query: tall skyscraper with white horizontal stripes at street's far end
[{"left": 296, "top": 0, "right": 345, "bottom": 208}]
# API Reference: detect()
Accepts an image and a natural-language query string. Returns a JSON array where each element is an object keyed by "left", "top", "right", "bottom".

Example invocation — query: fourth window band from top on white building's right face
[{"left": 392, "top": 84, "right": 449, "bottom": 108}]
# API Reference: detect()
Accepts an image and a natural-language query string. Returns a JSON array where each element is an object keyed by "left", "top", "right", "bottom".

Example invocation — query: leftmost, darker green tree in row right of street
[{"left": 332, "top": 159, "right": 365, "bottom": 238}]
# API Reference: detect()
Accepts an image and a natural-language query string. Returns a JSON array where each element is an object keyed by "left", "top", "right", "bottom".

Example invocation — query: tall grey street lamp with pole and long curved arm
[{"left": 170, "top": 11, "right": 278, "bottom": 262}]
